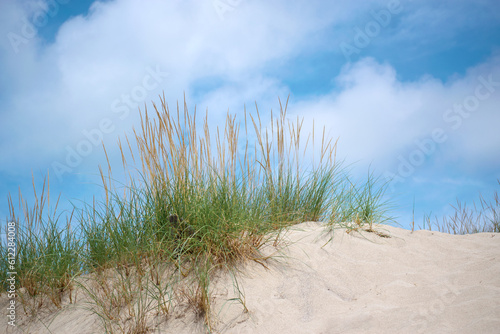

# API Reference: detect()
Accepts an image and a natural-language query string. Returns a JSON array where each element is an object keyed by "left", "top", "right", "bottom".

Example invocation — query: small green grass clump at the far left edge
[{"left": 0, "top": 175, "right": 82, "bottom": 315}]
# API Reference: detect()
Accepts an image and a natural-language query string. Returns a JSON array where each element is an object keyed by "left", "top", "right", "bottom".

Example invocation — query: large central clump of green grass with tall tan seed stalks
[{"left": 75, "top": 94, "right": 344, "bottom": 328}]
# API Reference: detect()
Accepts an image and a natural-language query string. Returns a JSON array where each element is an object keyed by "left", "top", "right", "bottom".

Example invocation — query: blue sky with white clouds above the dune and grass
[{"left": 0, "top": 0, "right": 500, "bottom": 230}]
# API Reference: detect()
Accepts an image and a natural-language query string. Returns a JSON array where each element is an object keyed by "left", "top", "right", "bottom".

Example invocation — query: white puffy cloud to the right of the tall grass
[{"left": 286, "top": 57, "right": 500, "bottom": 177}]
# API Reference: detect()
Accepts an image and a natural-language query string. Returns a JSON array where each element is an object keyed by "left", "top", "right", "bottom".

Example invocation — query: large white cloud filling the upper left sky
[{"left": 0, "top": 0, "right": 356, "bottom": 180}]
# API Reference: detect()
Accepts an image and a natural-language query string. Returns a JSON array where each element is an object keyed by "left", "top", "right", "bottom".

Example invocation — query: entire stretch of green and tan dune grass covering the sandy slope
[{"left": 0, "top": 97, "right": 396, "bottom": 333}]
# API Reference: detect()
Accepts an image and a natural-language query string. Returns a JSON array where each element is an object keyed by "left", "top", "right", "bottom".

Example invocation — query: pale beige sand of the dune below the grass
[{"left": 0, "top": 223, "right": 500, "bottom": 334}]
